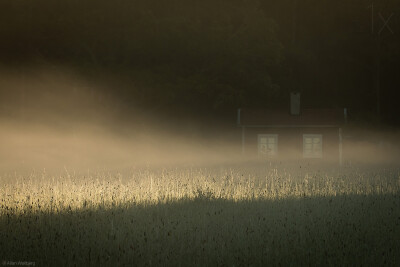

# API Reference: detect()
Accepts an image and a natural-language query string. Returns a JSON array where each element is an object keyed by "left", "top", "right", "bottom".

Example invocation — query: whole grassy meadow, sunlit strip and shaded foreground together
[{"left": 0, "top": 163, "right": 400, "bottom": 266}]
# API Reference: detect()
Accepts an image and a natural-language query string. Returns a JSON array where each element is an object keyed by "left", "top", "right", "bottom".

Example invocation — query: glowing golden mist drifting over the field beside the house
[{"left": 0, "top": 67, "right": 399, "bottom": 176}]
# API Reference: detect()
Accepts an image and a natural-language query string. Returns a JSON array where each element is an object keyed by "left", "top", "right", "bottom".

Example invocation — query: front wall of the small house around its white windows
[{"left": 245, "top": 127, "right": 339, "bottom": 162}]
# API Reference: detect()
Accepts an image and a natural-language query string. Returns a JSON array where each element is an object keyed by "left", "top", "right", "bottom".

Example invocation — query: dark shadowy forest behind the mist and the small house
[{"left": 0, "top": 0, "right": 400, "bottom": 125}]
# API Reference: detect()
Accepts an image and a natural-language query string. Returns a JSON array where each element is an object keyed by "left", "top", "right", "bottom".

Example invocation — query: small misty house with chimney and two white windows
[{"left": 237, "top": 93, "right": 347, "bottom": 164}]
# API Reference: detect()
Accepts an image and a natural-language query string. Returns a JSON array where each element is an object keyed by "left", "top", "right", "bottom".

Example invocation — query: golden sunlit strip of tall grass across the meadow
[{"left": 0, "top": 167, "right": 400, "bottom": 213}]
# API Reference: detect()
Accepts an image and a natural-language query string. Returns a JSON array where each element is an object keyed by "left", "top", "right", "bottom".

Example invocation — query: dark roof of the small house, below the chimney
[{"left": 238, "top": 108, "right": 346, "bottom": 127}]
